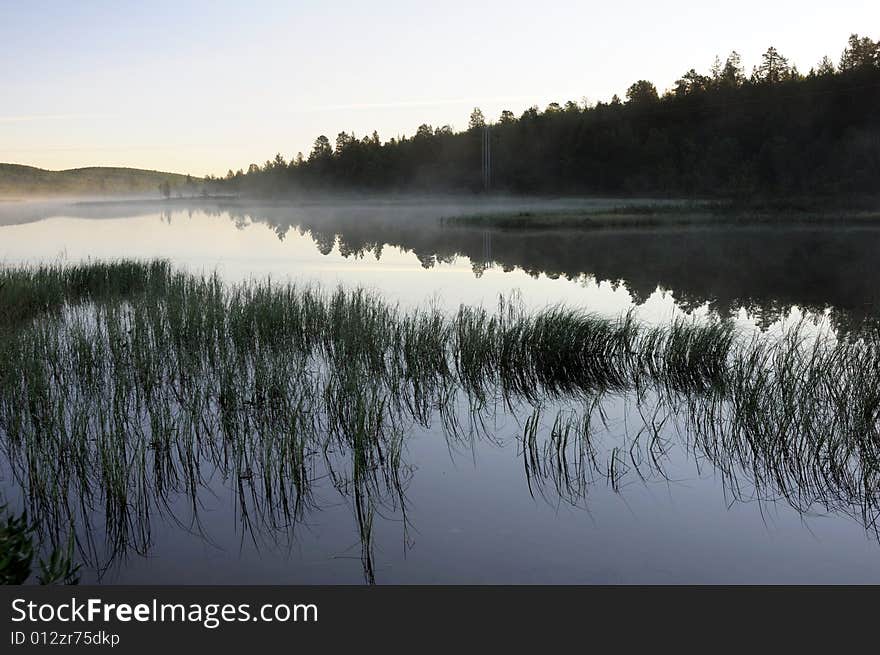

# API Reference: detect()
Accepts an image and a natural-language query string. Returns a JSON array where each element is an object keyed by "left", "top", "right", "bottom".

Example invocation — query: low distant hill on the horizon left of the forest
[{"left": 0, "top": 164, "right": 203, "bottom": 197}]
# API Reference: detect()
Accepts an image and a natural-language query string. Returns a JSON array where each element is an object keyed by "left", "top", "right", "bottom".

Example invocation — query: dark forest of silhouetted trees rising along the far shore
[{"left": 211, "top": 34, "right": 880, "bottom": 197}]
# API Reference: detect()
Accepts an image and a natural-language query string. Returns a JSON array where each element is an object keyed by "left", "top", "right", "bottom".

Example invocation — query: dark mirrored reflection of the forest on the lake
[{"left": 242, "top": 205, "right": 880, "bottom": 336}]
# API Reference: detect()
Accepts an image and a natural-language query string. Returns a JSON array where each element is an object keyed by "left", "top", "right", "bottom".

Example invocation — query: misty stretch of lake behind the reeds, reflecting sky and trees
[{"left": 0, "top": 204, "right": 880, "bottom": 329}]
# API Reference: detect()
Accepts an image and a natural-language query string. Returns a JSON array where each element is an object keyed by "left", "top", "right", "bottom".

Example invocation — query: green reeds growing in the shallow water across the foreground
[{"left": 0, "top": 261, "right": 880, "bottom": 580}]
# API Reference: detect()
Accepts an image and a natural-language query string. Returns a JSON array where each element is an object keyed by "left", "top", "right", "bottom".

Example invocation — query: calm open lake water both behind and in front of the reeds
[{"left": 0, "top": 197, "right": 880, "bottom": 583}]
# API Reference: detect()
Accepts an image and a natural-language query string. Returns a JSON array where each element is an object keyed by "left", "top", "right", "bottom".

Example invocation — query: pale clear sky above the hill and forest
[{"left": 0, "top": 0, "right": 880, "bottom": 175}]
